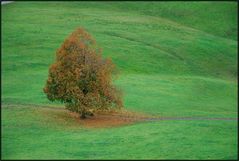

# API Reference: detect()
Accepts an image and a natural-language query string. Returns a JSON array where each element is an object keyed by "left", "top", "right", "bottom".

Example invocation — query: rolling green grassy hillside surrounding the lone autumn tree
[{"left": 1, "top": 2, "right": 238, "bottom": 159}]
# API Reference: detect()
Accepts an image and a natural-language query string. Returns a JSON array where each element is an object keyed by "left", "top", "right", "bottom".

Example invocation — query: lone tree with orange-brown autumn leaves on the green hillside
[{"left": 43, "top": 28, "right": 123, "bottom": 118}]
